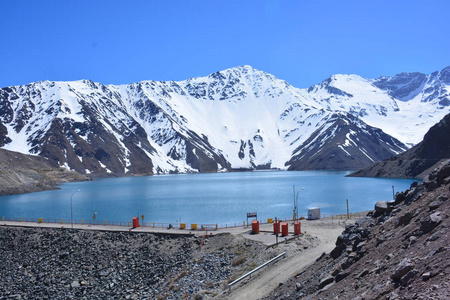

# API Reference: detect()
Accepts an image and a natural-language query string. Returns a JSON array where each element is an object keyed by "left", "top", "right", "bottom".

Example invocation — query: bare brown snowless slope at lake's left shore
[{"left": 0, "top": 149, "right": 89, "bottom": 196}]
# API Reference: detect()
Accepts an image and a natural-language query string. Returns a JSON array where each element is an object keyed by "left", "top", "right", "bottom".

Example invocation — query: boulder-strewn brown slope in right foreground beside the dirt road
[{"left": 266, "top": 160, "right": 450, "bottom": 299}]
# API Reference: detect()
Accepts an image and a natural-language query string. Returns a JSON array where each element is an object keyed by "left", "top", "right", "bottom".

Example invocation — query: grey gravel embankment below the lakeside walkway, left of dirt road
[{"left": 0, "top": 227, "right": 284, "bottom": 299}]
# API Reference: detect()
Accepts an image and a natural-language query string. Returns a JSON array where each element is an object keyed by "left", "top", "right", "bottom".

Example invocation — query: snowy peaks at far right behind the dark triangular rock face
[{"left": 307, "top": 67, "right": 450, "bottom": 146}]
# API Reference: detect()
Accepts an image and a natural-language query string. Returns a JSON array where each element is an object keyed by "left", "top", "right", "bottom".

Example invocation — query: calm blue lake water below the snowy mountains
[{"left": 0, "top": 171, "right": 414, "bottom": 224}]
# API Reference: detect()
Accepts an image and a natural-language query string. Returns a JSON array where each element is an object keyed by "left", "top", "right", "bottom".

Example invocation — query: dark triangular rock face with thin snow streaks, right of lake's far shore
[{"left": 286, "top": 114, "right": 407, "bottom": 170}]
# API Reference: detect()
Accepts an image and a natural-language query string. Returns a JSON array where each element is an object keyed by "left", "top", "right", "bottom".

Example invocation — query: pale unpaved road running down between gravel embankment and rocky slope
[{"left": 221, "top": 220, "right": 349, "bottom": 299}]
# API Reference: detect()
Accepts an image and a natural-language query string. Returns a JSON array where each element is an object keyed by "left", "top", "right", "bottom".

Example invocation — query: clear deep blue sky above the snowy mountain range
[{"left": 0, "top": 0, "right": 450, "bottom": 88}]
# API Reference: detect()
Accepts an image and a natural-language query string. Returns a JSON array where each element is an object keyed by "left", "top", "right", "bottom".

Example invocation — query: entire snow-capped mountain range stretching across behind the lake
[{"left": 0, "top": 66, "right": 450, "bottom": 174}]
